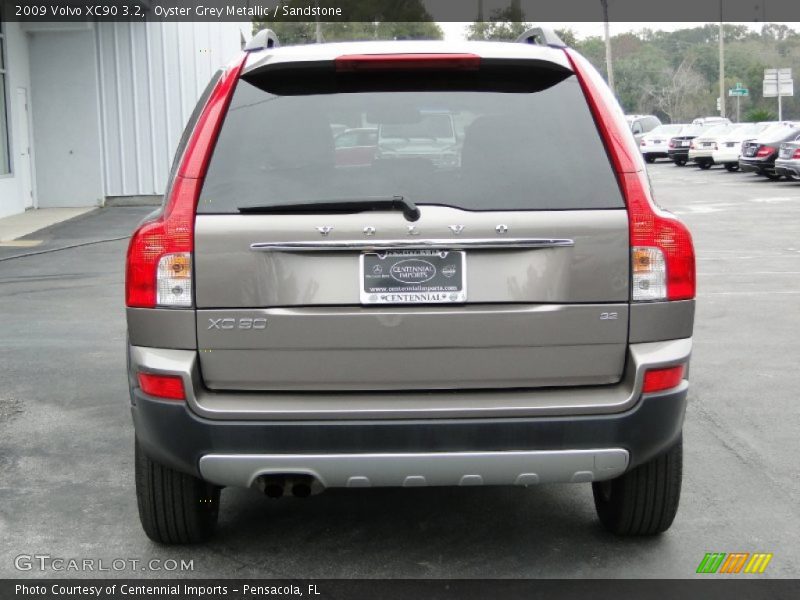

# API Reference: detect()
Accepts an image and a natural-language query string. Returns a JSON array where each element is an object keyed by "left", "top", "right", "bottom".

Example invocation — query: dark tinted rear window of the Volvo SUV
[{"left": 198, "top": 66, "right": 624, "bottom": 213}]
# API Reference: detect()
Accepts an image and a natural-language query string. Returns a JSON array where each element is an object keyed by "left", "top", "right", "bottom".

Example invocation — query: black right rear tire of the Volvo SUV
[{"left": 592, "top": 438, "right": 683, "bottom": 535}]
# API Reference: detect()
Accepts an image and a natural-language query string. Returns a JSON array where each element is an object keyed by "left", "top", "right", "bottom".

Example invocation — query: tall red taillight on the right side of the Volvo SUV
[{"left": 565, "top": 49, "right": 695, "bottom": 300}]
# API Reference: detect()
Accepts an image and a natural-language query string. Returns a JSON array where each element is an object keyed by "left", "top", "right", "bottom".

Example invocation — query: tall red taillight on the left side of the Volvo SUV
[{"left": 125, "top": 56, "right": 247, "bottom": 308}]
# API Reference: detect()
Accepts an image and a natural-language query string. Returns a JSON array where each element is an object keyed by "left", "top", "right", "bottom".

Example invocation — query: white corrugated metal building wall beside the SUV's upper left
[{"left": 95, "top": 23, "right": 244, "bottom": 196}]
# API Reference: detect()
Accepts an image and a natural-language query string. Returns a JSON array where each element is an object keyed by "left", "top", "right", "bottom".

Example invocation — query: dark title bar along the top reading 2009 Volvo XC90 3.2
[{"left": 0, "top": 0, "right": 800, "bottom": 22}]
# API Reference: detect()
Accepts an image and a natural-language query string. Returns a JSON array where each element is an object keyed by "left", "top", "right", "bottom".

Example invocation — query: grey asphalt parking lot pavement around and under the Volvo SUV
[{"left": 0, "top": 161, "right": 800, "bottom": 578}]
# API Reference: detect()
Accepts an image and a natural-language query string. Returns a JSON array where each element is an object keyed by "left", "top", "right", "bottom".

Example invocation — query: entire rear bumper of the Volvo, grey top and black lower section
[{"left": 129, "top": 336, "right": 692, "bottom": 487}]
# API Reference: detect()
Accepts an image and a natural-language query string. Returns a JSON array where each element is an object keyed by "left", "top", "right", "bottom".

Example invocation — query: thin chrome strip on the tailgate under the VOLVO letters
[{"left": 250, "top": 238, "right": 575, "bottom": 252}]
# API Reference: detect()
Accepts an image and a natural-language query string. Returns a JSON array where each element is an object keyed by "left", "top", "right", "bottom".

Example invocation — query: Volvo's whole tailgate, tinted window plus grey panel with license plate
[{"left": 195, "top": 50, "right": 629, "bottom": 391}]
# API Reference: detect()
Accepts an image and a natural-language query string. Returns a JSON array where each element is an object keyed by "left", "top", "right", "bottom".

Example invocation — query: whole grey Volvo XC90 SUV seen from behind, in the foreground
[{"left": 126, "top": 29, "right": 695, "bottom": 543}]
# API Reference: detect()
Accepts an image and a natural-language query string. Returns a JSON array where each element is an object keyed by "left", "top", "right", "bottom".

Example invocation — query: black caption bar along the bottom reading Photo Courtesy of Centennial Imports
[{"left": 0, "top": 576, "right": 800, "bottom": 600}]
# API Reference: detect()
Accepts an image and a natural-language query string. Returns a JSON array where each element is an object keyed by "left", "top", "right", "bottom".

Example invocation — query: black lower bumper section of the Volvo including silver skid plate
[{"left": 132, "top": 381, "right": 688, "bottom": 487}]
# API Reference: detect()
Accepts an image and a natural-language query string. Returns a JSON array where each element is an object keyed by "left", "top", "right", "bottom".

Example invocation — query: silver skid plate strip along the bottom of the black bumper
[{"left": 199, "top": 448, "right": 629, "bottom": 487}]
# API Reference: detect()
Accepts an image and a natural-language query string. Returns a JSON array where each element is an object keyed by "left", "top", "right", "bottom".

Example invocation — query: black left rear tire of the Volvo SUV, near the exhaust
[{"left": 135, "top": 440, "right": 220, "bottom": 544}]
